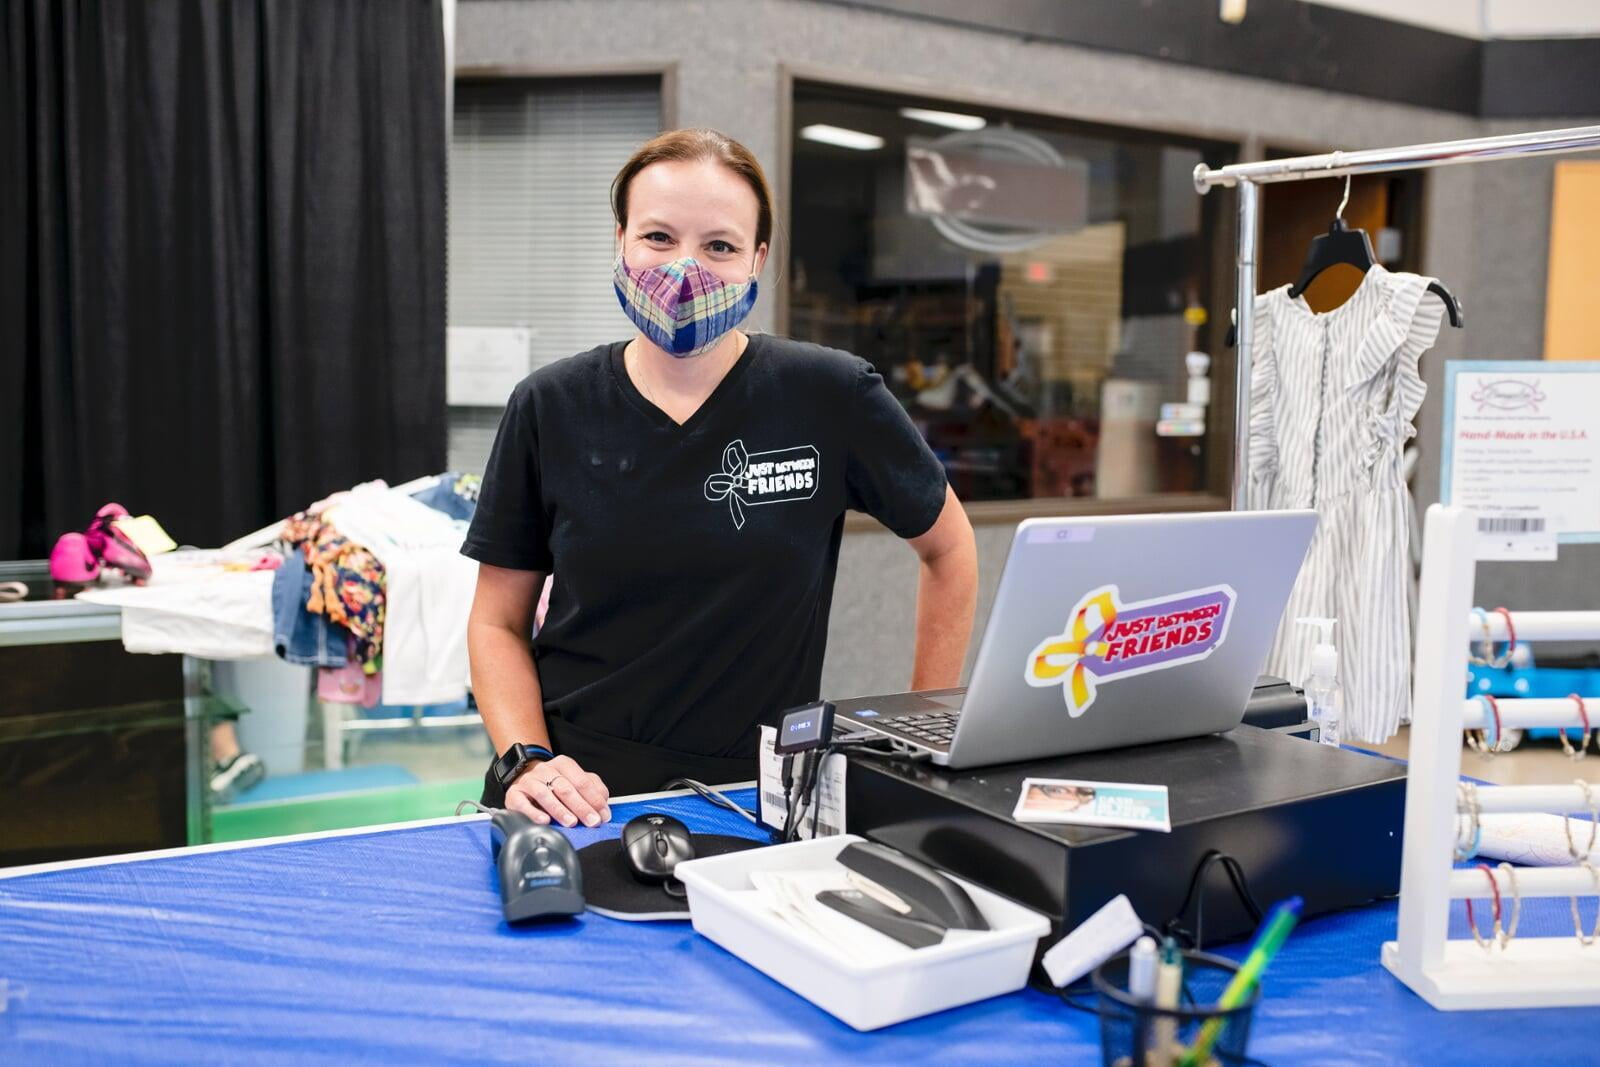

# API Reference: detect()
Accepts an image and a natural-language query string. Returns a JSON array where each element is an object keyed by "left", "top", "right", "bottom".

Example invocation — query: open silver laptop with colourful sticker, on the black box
[{"left": 834, "top": 510, "right": 1317, "bottom": 768}]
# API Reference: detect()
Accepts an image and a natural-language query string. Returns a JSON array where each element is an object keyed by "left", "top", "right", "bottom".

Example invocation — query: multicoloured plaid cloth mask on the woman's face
[{"left": 611, "top": 256, "right": 755, "bottom": 358}]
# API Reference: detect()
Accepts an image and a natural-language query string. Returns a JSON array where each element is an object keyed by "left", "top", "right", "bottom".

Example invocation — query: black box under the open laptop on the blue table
[{"left": 845, "top": 726, "right": 1405, "bottom": 942}]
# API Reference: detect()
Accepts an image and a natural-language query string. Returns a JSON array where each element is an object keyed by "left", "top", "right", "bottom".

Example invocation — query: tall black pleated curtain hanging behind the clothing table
[{"left": 0, "top": 0, "right": 446, "bottom": 560}]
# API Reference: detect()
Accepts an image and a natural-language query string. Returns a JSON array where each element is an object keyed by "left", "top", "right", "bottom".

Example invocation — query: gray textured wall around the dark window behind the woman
[{"left": 456, "top": 0, "right": 1600, "bottom": 696}]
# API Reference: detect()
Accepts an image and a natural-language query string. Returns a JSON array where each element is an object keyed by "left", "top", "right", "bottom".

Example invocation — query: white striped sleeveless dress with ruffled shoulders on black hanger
[{"left": 1246, "top": 267, "right": 1443, "bottom": 741}]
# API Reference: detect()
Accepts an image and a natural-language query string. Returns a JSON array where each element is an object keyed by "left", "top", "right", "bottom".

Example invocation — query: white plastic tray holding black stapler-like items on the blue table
[{"left": 677, "top": 833, "right": 1050, "bottom": 1030}]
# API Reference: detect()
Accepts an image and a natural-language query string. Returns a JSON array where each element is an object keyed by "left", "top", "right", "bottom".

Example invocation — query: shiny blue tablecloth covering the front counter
[{"left": 0, "top": 793, "right": 1600, "bottom": 1067}]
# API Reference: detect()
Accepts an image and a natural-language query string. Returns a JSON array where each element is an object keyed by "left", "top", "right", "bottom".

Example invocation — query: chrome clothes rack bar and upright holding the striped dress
[{"left": 1195, "top": 126, "right": 1600, "bottom": 510}]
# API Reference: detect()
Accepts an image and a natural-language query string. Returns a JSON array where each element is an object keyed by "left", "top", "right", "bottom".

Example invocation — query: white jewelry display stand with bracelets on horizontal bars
[{"left": 1382, "top": 504, "right": 1600, "bottom": 1011}]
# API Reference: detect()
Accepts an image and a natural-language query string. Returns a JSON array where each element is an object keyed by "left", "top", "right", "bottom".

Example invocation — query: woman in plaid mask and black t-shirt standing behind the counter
[{"left": 462, "top": 130, "right": 978, "bottom": 825}]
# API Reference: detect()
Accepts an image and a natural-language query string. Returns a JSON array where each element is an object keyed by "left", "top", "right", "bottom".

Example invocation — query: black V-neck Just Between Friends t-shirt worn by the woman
[{"left": 462, "top": 334, "right": 946, "bottom": 758}]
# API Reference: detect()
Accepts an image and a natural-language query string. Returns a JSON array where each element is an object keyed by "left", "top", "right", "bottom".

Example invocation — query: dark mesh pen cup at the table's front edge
[{"left": 1094, "top": 952, "right": 1261, "bottom": 1067}]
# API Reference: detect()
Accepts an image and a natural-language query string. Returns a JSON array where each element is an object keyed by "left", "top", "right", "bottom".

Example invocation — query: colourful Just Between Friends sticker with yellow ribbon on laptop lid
[{"left": 1022, "top": 585, "right": 1237, "bottom": 718}]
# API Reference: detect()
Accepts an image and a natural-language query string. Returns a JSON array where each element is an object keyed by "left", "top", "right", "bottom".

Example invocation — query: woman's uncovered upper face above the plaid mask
[{"left": 616, "top": 160, "right": 766, "bottom": 285}]
